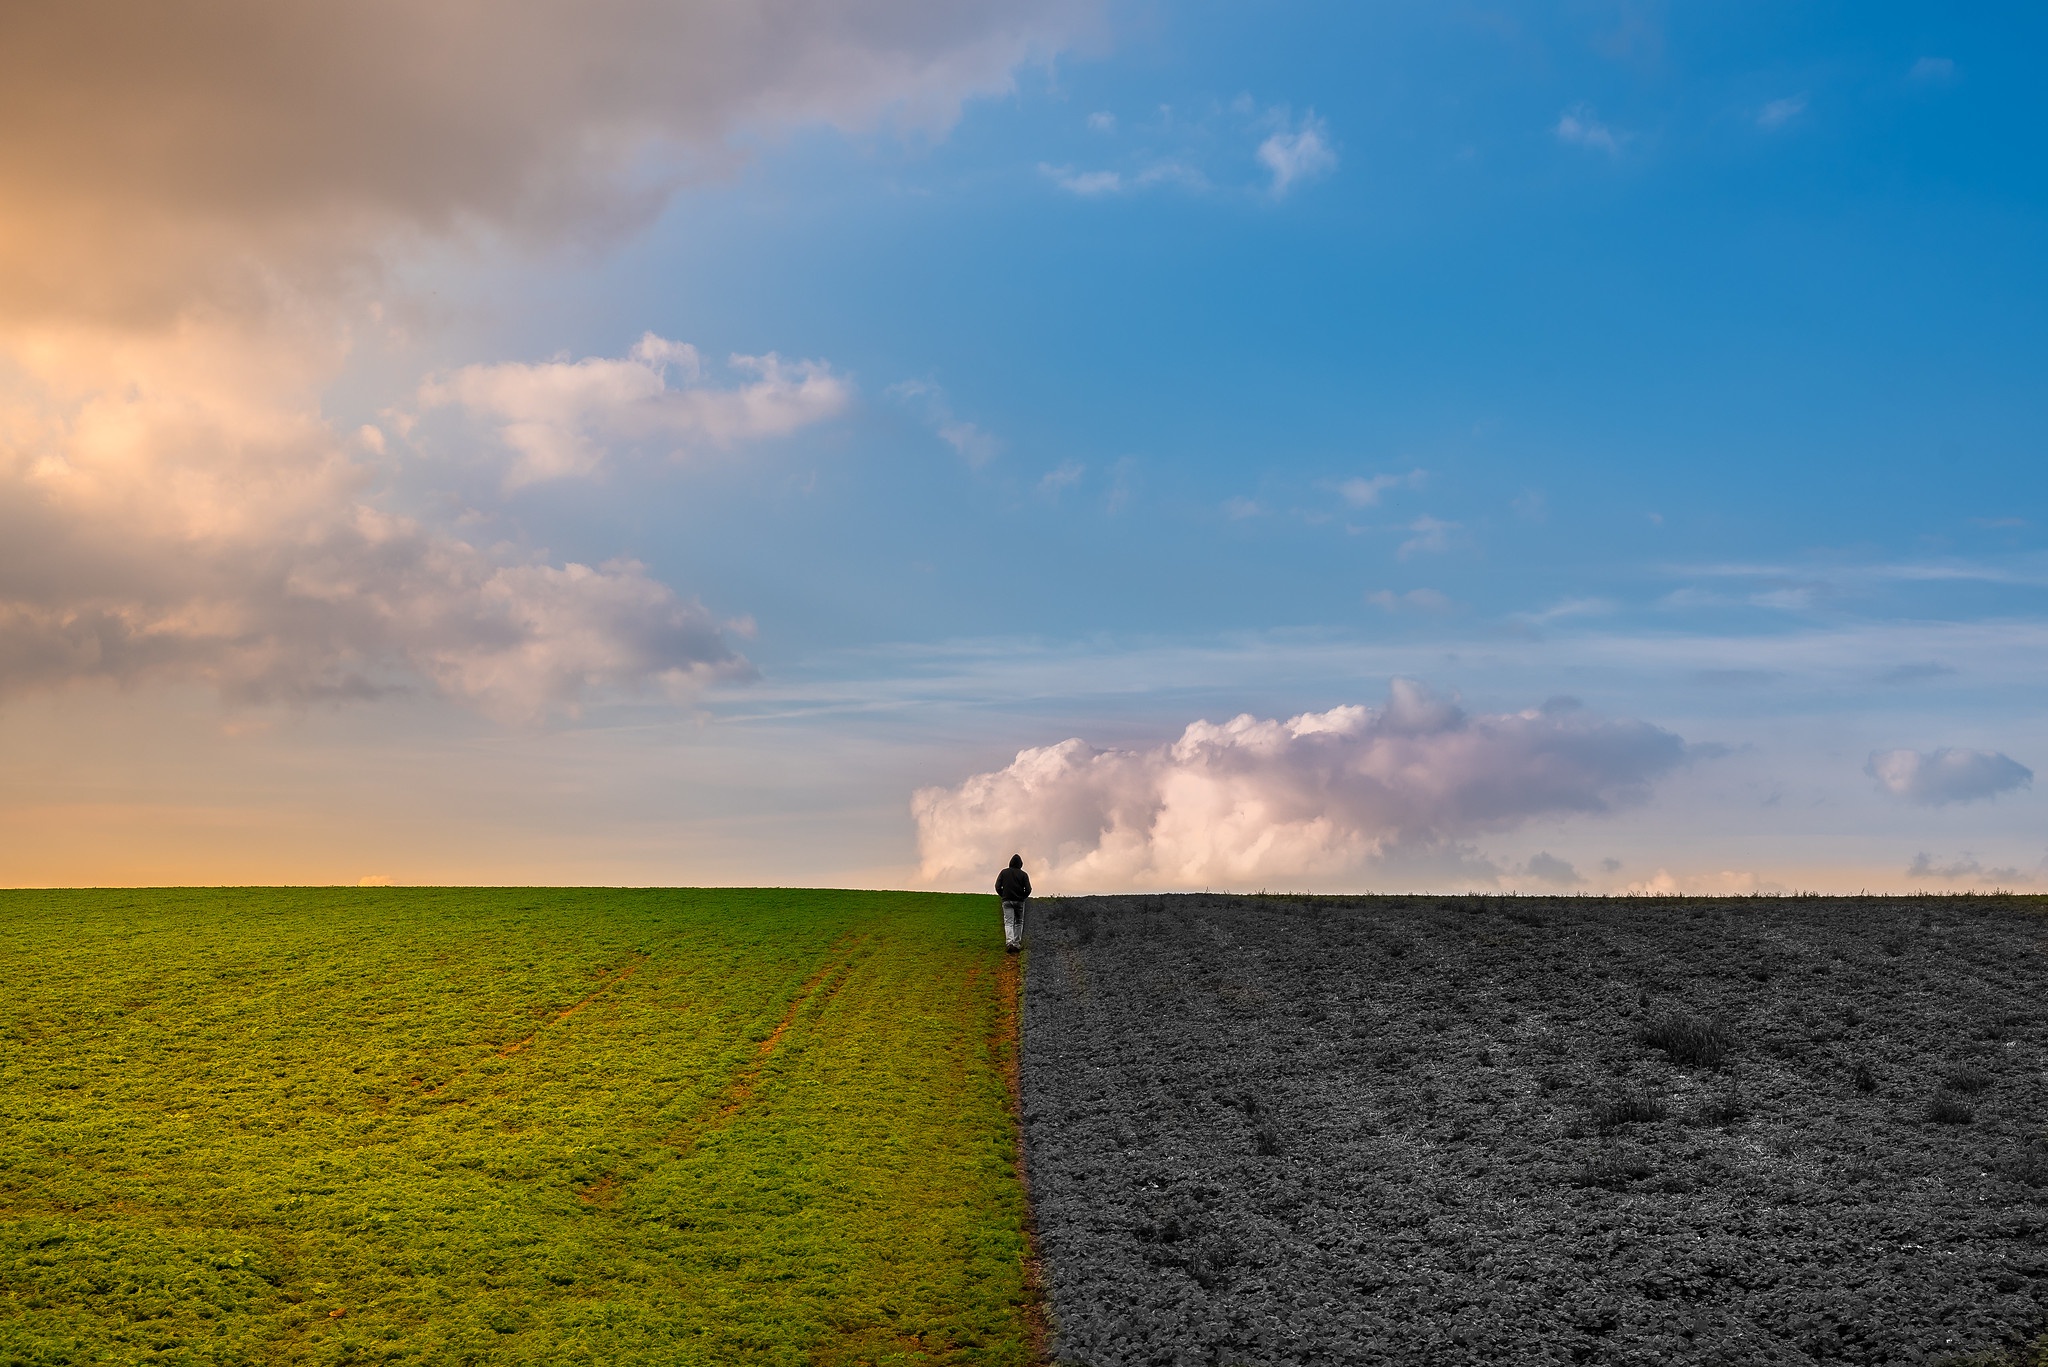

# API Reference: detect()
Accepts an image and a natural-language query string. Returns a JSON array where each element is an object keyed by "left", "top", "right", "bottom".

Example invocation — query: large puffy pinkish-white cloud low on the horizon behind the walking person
[{"left": 911, "top": 678, "right": 1686, "bottom": 889}]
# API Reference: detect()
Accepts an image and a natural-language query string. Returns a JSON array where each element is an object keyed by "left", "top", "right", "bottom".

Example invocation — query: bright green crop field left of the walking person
[{"left": 0, "top": 889, "right": 1030, "bottom": 1365}]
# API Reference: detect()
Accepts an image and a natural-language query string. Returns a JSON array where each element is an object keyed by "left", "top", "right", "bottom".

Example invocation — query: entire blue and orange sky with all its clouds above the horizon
[{"left": 0, "top": 0, "right": 2048, "bottom": 892}]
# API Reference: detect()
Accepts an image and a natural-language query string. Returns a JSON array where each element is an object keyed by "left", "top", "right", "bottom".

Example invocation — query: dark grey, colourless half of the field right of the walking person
[{"left": 1022, "top": 896, "right": 2048, "bottom": 1367}]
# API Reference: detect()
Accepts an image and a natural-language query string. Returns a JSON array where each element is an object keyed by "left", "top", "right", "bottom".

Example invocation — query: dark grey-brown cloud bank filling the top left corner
[{"left": 0, "top": 0, "right": 1096, "bottom": 320}]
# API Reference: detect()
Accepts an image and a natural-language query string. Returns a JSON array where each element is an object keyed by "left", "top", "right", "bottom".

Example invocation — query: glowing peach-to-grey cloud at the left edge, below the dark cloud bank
[{"left": 0, "top": 324, "right": 752, "bottom": 721}]
